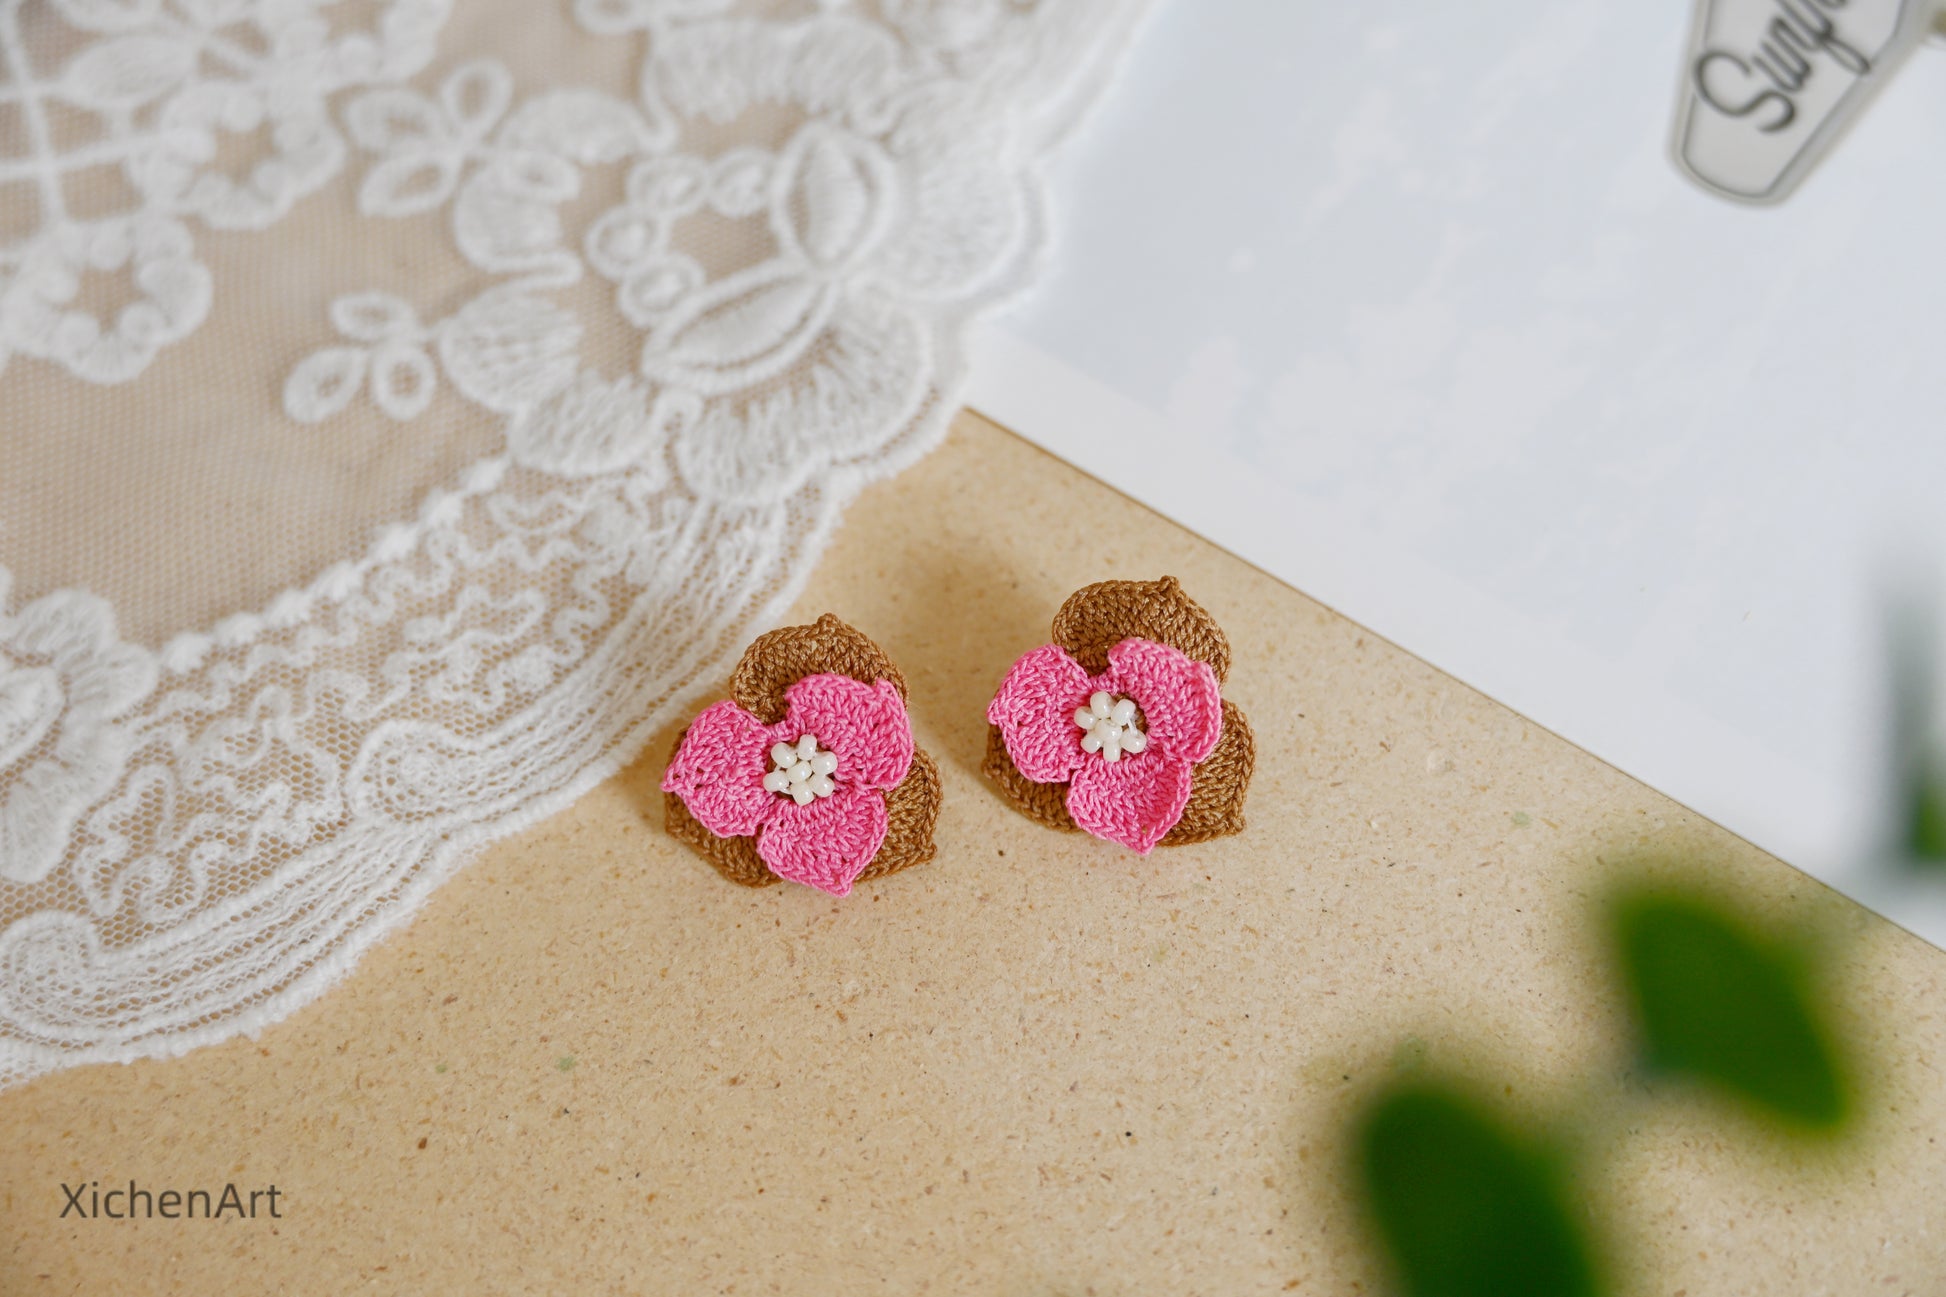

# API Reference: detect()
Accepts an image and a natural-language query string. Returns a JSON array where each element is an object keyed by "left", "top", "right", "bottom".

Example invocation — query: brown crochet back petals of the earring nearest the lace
[{"left": 662, "top": 613, "right": 940, "bottom": 888}]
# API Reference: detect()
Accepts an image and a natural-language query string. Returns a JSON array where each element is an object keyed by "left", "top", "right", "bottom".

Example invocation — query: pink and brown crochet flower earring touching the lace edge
[{"left": 662, "top": 613, "right": 940, "bottom": 896}]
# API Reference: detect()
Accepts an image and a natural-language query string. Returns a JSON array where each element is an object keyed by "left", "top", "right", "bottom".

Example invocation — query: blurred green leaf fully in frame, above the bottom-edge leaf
[{"left": 1613, "top": 894, "right": 1849, "bottom": 1130}]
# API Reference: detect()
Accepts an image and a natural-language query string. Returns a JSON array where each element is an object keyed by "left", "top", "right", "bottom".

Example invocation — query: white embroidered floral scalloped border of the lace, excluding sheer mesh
[{"left": 0, "top": 0, "right": 1138, "bottom": 1085}]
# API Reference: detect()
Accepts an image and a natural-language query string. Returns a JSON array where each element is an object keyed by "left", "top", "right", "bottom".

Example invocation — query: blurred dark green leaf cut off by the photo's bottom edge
[{"left": 1356, "top": 1081, "right": 1602, "bottom": 1297}]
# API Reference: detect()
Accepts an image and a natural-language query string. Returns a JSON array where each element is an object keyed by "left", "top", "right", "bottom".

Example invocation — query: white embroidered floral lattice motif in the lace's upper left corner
[{"left": 0, "top": 0, "right": 450, "bottom": 384}]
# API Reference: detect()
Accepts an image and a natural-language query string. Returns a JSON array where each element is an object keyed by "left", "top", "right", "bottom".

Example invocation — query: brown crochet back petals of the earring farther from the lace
[{"left": 981, "top": 576, "right": 1257, "bottom": 847}]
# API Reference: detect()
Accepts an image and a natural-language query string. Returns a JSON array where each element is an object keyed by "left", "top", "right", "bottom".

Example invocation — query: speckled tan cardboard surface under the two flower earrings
[{"left": 0, "top": 415, "right": 1946, "bottom": 1297}]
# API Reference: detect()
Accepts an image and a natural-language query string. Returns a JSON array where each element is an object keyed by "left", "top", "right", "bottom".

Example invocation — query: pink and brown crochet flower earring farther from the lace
[{"left": 985, "top": 576, "right": 1257, "bottom": 855}]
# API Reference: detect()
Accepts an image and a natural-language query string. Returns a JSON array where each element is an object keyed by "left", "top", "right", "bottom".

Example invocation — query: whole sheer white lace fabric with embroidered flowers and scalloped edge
[{"left": 0, "top": 0, "right": 1140, "bottom": 1085}]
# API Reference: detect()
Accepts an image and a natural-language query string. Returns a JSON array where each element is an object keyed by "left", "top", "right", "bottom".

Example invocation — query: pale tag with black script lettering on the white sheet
[{"left": 1674, "top": 0, "right": 1940, "bottom": 203}]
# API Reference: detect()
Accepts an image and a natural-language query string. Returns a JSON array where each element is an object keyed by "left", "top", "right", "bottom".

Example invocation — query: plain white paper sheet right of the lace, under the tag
[{"left": 971, "top": 0, "right": 1946, "bottom": 943}]
